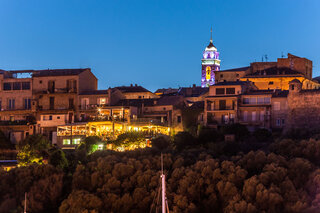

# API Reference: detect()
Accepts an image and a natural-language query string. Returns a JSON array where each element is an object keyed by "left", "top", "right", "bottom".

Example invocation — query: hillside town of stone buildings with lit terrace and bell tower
[{"left": 0, "top": 36, "right": 320, "bottom": 149}]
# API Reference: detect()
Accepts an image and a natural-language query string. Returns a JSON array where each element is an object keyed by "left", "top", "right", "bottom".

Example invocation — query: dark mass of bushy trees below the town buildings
[{"left": 0, "top": 125, "right": 320, "bottom": 213}]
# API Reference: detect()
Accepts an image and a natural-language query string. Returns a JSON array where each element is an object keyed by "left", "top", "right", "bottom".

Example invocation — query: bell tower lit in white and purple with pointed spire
[{"left": 201, "top": 28, "right": 220, "bottom": 87}]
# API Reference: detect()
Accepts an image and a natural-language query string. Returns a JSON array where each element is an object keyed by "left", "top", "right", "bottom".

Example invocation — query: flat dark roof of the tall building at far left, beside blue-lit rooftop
[{"left": 32, "top": 68, "right": 90, "bottom": 77}]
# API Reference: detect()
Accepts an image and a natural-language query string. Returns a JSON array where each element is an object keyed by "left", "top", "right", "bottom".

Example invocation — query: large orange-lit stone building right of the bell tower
[{"left": 215, "top": 53, "right": 320, "bottom": 90}]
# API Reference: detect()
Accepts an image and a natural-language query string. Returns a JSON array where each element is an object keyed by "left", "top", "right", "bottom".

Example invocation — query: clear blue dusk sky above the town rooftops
[{"left": 0, "top": 0, "right": 320, "bottom": 91}]
